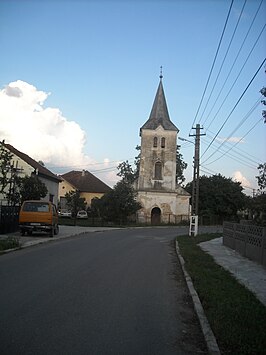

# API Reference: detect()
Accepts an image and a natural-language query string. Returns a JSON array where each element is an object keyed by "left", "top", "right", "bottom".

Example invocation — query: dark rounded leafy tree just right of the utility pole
[{"left": 186, "top": 174, "right": 247, "bottom": 219}]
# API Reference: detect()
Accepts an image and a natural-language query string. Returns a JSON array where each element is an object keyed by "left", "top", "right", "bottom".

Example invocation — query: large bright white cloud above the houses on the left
[{"left": 0, "top": 80, "right": 117, "bottom": 185}]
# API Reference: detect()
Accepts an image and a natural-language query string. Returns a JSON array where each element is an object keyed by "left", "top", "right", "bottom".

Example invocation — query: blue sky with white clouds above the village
[{"left": 0, "top": 0, "right": 266, "bottom": 194}]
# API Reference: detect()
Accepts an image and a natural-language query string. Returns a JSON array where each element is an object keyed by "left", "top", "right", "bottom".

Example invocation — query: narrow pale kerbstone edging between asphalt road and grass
[{"left": 176, "top": 241, "right": 221, "bottom": 355}]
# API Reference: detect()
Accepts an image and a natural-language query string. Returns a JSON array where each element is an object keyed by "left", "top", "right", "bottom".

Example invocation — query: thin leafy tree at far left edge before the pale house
[{"left": 0, "top": 140, "right": 13, "bottom": 195}]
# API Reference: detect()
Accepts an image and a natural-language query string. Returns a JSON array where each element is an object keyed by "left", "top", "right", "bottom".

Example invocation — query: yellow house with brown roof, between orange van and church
[{"left": 59, "top": 170, "right": 112, "bottom": 209}]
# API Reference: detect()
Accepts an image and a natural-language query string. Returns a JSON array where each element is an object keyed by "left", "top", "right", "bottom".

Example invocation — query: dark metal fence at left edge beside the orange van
[{"left": 0, "top": 206, "right": 19, "bottom": 234}]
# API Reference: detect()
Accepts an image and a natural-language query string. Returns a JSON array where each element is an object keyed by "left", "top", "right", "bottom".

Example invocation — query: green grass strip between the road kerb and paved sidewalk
[{"left": 177, "top": 234, "right": 266, "bottom": 355}]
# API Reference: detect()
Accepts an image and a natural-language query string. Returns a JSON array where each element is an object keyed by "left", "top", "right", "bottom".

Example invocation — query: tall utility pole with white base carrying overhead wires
[{"left": 189, "top": 124, "right": 205, "bottom": 237}]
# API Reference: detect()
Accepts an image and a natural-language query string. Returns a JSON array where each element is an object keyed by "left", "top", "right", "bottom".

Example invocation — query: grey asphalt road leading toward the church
[{"left": 0, "top": 228, "right": 207, "bottom": 355}]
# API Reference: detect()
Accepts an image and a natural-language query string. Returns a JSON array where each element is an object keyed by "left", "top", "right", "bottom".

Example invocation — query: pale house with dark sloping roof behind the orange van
[{"left": 0, "top": 143, "right": 61, "bottom": 204}]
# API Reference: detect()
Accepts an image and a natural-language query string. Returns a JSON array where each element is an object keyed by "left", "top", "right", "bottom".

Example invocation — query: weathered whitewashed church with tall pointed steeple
[{"left": 136, "top": 75, "right": 190, "bottom": 224}]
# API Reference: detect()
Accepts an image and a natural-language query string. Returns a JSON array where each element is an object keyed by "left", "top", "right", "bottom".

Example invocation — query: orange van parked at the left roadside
[{"left": 19, "top": 200, "right": 59, "bottom": 237}]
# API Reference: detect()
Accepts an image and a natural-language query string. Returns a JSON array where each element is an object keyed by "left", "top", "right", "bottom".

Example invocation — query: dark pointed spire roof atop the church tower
[{"left": 140, "top": 76, "right": 179, "bottom": 134}]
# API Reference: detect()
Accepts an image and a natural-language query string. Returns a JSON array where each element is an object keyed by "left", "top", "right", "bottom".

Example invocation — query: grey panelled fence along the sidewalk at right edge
[{"left": 223, "top": 222, "right": 266, "bottom": 267}]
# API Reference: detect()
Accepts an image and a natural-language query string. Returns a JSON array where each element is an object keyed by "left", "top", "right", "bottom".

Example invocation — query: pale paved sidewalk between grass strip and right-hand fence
[{"left": 199, "top": 237, "right": 266, "bottom": 306}]
